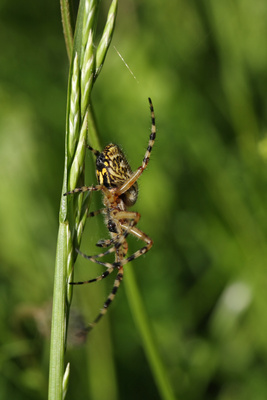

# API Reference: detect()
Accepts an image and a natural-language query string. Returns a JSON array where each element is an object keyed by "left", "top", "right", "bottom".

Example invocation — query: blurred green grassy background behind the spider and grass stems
[{"left": 0, "top": 0, "right": 267, "bottom": 400}]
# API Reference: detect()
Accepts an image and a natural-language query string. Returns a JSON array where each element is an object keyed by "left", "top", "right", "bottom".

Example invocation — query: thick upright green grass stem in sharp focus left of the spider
[{"left": 48, "top": 0, "right": 119, "bottom": 400}]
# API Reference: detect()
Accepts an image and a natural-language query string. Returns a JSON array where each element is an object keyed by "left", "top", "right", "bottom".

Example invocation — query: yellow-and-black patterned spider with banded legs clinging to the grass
[{"left": 64, "top": 98, "right": 156, "bottom": 331}]
